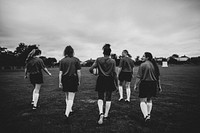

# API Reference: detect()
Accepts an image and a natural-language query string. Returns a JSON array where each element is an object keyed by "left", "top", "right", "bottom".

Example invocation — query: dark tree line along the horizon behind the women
[{"left": 0, "top": 43, "right": 200, "bottom": 69}]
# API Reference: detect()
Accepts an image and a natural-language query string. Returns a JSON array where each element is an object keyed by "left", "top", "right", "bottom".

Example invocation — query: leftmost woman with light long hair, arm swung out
[{"left": 25, "top": 49, "right": 51, "bottom": 110}]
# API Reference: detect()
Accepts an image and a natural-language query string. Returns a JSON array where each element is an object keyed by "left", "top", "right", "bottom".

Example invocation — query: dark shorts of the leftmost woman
[{"left": 29, "top": 73, "right": 43, "bottom": 86}]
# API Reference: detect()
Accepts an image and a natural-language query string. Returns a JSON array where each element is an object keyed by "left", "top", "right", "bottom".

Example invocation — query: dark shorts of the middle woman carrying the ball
[{"left": 96, "top": 76, "right": 116, "bottom": 92}]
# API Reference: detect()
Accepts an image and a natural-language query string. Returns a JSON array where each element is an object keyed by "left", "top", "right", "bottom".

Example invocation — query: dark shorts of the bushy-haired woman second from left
[{"left": 61, "top": 76, "right": 78, "bottom": 92}]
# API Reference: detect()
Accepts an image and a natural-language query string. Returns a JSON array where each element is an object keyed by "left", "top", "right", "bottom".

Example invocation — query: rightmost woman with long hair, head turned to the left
[{"left": 134, "top": 52, "right": 162, "bottom": 122}]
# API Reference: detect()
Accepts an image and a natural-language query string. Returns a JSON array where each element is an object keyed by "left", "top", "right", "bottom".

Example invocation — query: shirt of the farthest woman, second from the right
[{"left": 119, "top": 57, "right": 134, "bottom": 72}]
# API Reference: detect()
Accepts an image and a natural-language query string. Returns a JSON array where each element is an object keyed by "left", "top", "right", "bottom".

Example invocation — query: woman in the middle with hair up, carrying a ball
[{"left": 89, "top": 44, "right": 117, "bottom": 124}]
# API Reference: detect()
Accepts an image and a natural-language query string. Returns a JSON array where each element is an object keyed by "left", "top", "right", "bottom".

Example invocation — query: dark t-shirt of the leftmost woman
[{"left": 26, "top": 57, "right": 45, "bottom": 74}]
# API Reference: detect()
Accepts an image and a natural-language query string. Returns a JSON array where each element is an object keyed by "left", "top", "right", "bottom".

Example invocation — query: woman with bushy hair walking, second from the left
[{"left": 59, "top": 46, "right": 81, "bottom": 121}]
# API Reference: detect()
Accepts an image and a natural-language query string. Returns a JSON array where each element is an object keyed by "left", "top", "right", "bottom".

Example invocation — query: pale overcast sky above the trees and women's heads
[{"left": 0, "top": 0, "right": 200, "bottom": 61}]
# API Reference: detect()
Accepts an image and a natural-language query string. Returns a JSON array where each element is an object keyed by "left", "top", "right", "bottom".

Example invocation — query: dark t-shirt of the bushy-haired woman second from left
[{"left": 59, "top": 56, "right": 81, "bottom": 76}]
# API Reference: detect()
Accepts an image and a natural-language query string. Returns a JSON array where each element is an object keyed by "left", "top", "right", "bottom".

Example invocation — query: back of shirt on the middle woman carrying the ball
[{"left": 95, "top": 57, "right": 116, "bottom": 76}]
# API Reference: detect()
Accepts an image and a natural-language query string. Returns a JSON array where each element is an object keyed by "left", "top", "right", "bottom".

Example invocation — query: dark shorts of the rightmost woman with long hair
[{"left": 139, "top": 81, "right": 158, "bottom": 98}]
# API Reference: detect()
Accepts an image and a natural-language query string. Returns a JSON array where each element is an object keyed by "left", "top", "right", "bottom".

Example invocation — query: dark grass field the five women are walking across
[{"left": 0, "top": 65, "right": 200, "bottom": 133}]
